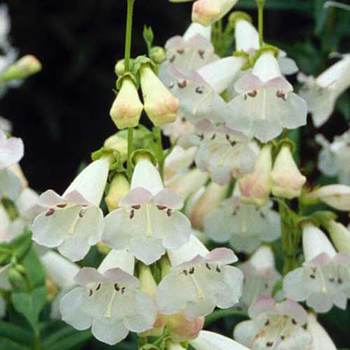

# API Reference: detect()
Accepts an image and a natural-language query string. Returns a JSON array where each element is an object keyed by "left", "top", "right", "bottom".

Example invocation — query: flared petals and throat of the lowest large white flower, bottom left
[{"left": 60, "top": 268, "right": 156, "bottom": 345}]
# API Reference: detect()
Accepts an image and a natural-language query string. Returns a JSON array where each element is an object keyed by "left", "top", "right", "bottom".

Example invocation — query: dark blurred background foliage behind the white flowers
[{"left": 0, "top": 0, "right": 350, "bottom": 350}]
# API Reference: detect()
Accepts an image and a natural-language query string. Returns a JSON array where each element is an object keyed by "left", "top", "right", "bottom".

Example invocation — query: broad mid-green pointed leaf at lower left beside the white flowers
[{"left": 11, "top": 286, "right": 47, "bottom": 334}]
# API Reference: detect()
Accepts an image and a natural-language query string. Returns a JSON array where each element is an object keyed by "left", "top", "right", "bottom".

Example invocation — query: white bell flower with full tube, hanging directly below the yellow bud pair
[{"left": 103, "top": 159, "right": 191, "bottom": 265}]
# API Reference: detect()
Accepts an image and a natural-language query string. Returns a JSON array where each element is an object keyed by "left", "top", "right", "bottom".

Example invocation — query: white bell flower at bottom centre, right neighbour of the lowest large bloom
[{"left": 156, "top": 236, "right": 243, "bottom": 320}]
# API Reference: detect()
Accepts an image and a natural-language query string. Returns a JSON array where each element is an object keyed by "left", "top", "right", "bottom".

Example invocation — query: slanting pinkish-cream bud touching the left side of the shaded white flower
[{"left": 189, "top": 182, "right": 228, "bottom": 230}]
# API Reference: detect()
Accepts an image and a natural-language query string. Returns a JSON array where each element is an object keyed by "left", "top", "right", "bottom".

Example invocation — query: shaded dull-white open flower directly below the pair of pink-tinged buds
[{"left": 204, "top": 195, "right": 281, "bottom": 253}]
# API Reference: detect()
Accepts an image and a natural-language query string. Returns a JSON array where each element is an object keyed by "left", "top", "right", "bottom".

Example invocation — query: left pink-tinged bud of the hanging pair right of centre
[{"left": 239, "top": 145, "right": 272, "bottom": 206}]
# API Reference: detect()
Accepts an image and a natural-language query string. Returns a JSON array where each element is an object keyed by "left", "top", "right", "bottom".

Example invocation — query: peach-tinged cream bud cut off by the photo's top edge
[{"left": 192, "top": 0, "right": 238, "bottom": 26}]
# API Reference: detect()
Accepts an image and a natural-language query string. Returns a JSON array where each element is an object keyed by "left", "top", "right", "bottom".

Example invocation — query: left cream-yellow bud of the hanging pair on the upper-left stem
[{"left": 110, "top": 77, "right": 143, "bottom": 129}]
